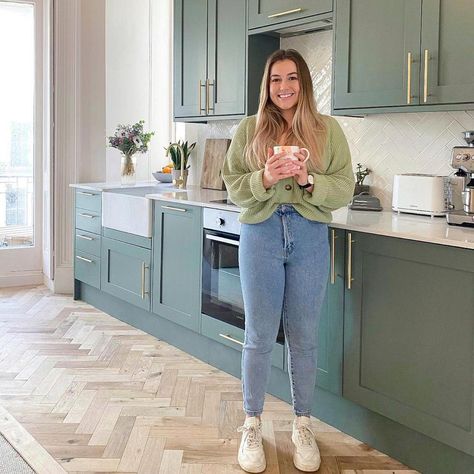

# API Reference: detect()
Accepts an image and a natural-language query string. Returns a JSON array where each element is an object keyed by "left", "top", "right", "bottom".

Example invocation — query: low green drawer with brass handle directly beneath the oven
[{"left": 201, "top": 314, "right": 285, "bottom": 370}]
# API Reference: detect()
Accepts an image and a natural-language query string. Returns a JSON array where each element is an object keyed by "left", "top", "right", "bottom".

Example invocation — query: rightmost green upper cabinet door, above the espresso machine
[{"left": 420, "top": 0, "right": 474, "bottom": 104}]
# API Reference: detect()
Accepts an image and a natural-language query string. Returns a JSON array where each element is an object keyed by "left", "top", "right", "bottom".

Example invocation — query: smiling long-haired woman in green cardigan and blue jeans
[{"left": 223, "top": 49, "right": 354, "bottom": 472}]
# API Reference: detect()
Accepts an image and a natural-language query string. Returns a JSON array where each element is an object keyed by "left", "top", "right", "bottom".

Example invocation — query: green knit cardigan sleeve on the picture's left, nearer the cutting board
[{"left": 222, "top": 117, "right": 275, "bottom": 209}]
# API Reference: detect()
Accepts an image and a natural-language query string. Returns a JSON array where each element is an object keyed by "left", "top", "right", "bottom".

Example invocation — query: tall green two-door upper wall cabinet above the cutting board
[{"left": 174, "top": 0, "right": 247, "bottom": 121}]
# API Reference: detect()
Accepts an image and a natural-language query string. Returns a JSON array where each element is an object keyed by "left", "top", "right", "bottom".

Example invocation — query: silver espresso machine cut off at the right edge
[{"left": 446, "top": 130, "right": 474, "bottom": 227}]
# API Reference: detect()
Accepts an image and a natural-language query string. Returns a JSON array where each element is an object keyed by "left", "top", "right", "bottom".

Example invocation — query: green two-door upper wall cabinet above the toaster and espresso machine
[{"left": 333, "top": 0, "right": 474, "bottom": 115}]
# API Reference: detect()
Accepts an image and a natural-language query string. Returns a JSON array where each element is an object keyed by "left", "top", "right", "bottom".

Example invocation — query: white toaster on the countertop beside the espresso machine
[{"left": 392, "top": 173, "right": 449, "bottom": 216}]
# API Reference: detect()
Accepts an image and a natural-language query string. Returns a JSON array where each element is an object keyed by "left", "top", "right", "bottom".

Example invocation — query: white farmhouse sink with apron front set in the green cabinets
[{"left": 102, "top": 186, "right": 157, "bottom": 237}]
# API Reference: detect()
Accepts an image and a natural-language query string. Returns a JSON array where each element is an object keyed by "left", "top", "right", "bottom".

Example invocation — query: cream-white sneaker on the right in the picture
[{"left": 291, "top": 416, "right": 321, "bottom": 472}]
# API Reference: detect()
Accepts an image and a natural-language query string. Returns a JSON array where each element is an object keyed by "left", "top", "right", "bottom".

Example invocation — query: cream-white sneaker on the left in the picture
[{"left": 237, "top": 416, "right": 267, "bottom": 473}]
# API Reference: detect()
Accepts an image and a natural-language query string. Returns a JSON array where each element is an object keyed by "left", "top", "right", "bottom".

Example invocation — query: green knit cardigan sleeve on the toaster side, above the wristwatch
[{"left": 303, "top": 118, "right": 355, "bottom": 211}]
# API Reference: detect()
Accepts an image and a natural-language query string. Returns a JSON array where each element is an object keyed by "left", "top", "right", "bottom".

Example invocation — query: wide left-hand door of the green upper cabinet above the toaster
[{"left": 333, "top": 0, "right": 421, "bottom": 109}]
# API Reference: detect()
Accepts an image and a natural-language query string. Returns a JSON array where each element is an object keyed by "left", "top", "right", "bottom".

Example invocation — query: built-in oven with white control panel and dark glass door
[{"left": 201, "top": 208, "right": 284, "bottom": 344}]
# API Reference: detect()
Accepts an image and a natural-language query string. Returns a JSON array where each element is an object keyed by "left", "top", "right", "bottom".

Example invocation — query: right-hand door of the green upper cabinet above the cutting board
[{"left": 207, "top": 0, "right": 247, "bottom": 115}]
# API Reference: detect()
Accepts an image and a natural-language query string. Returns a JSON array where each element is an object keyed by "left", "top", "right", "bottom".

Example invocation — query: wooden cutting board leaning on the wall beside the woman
[{"left": 201, "top": 138, "right": 230, "bottom": 191}]
